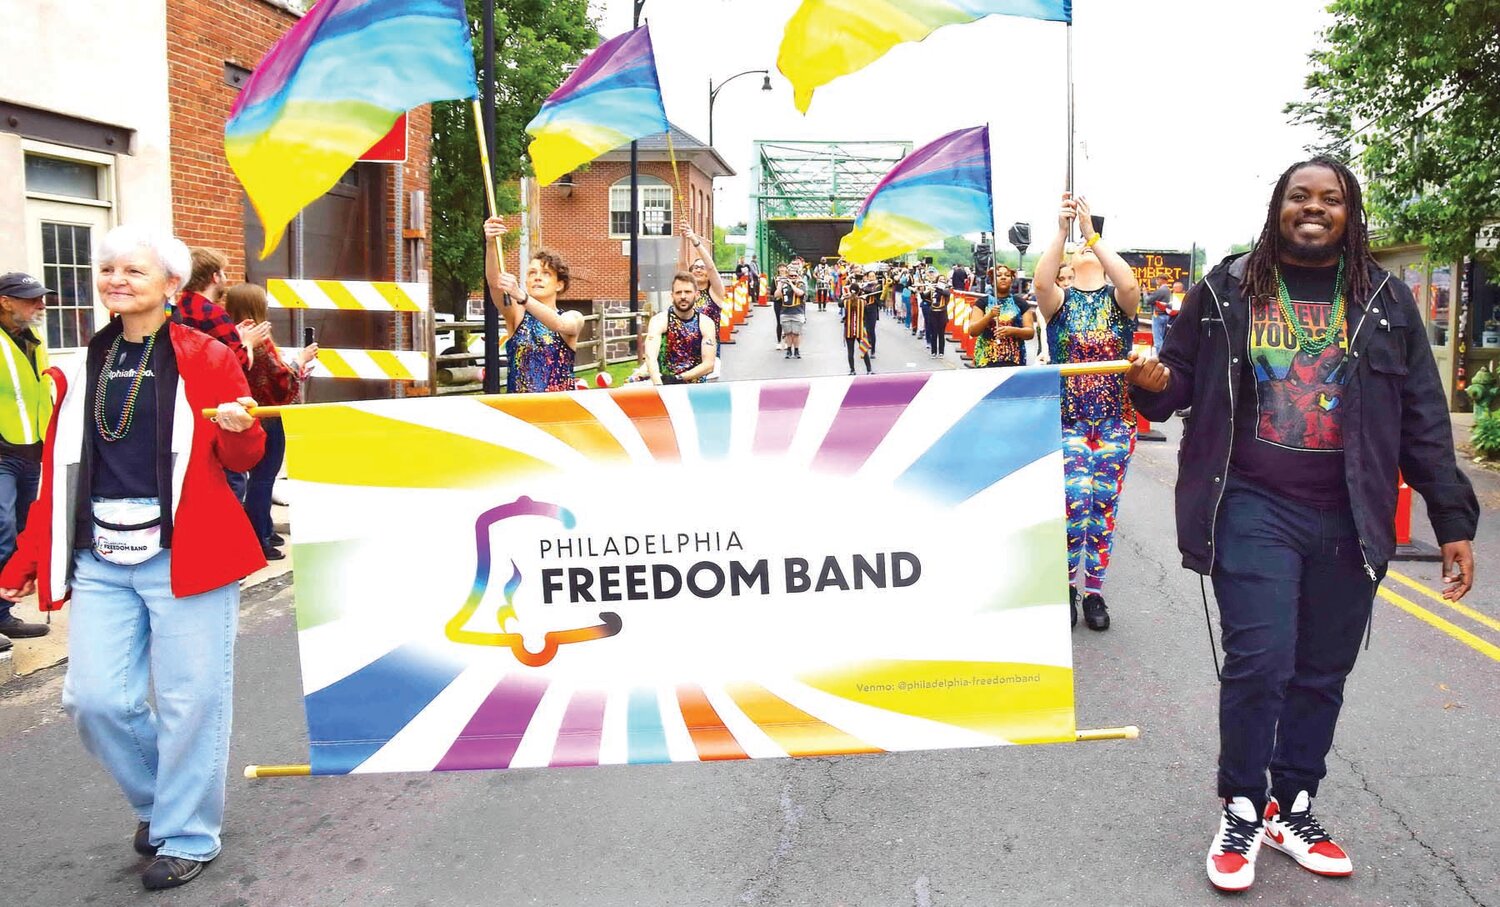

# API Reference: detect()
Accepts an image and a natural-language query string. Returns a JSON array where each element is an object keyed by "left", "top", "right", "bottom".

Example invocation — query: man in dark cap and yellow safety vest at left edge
[{"left": 0, "top": 271, "right": 56, "bottom": 652}]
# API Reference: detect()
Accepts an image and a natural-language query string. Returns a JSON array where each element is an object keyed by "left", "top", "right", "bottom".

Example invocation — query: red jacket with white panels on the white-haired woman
[{"left": 0, "top": 322, "right": 266, "bottom": 612}]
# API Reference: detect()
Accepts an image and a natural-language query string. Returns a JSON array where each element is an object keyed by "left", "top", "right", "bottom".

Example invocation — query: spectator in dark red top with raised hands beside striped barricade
[{"left": 224, "top": 283, "right": 318, "bottom": 561}]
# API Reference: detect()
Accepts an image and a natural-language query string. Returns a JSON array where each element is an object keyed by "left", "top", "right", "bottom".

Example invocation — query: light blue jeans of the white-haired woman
[{"left": 63, "top": 550, "right": 240, "bottom": 861}]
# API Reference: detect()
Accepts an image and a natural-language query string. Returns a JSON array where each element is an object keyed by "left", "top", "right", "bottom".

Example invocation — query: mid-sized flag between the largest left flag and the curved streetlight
[{"left": 527, "top": 25, "right": 668, "bottom": 186}]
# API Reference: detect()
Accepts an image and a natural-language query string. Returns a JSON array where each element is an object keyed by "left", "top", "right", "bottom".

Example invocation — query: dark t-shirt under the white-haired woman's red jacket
[{"left": 89, "top": 330, "right": 161, "bottom": 498}]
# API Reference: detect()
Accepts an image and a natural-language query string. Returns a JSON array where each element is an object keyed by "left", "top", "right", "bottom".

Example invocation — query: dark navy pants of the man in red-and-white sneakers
[{"left": 1214, "top": 475, "right": 1376, "bottom": 810}]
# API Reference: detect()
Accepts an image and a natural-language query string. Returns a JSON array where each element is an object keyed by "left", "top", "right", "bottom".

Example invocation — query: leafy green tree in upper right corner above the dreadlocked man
[{"left": 1287, "top": 0, "right": 1500, "bottom": 262}]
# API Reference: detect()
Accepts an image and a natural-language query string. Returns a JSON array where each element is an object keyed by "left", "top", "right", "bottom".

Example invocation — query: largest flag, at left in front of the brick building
[{"left": 224, "top": 0, "right": 477, "bottom": 258}]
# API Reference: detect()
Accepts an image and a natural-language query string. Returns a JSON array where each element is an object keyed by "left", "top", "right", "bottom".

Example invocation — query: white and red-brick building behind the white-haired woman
[{"left": 0, "top": 0, "right": 431, "bottom": 399}]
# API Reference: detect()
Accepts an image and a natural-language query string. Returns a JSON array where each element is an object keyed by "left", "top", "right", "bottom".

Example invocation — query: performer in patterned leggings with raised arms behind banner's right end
[{"left": 1034, "top": 192, "right": 1140, "bottom": 630}]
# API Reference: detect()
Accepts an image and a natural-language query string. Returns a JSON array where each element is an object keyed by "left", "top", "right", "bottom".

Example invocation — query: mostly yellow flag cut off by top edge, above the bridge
[{"left": 777, "top": 0, "right": 1073, "bottom": 114}]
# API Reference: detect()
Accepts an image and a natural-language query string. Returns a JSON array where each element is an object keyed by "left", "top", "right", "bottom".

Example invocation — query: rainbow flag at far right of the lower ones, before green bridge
[{"left": 839, "top": 126, "right": 995, "bottom": 262}]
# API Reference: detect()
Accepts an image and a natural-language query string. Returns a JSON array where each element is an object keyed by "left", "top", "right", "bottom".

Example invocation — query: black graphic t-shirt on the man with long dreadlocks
[{"left": 1230, "top": 265, "right": 1349, "bottom": 505}]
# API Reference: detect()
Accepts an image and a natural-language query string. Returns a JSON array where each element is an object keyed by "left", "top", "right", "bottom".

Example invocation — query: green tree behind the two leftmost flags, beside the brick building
[{"left": 431, "top": 0, "right": 599, "bottom": 312}]
